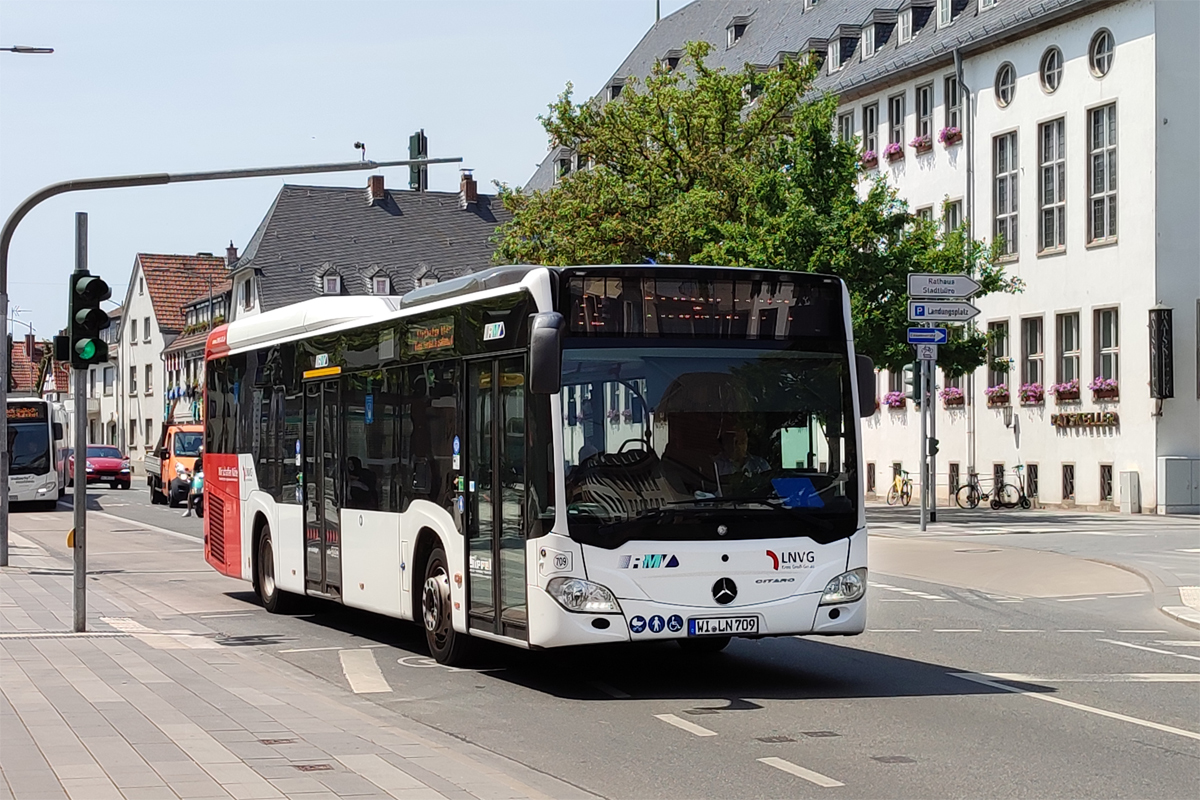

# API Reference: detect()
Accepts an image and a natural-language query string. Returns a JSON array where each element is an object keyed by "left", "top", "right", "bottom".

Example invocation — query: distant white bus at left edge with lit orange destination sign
[{"left": 7, "top": 397, "right": 67, "bottom": 511}]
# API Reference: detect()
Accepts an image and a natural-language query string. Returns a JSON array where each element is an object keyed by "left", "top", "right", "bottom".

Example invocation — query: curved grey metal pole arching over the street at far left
[{"left": 0, "top": 153, "right": 462, "bottom": 566}]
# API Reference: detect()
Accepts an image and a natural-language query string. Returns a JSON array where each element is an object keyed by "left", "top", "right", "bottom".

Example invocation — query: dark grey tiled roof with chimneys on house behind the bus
[{"left": 233, "top": 186, "right": 511, "bottom": 311}]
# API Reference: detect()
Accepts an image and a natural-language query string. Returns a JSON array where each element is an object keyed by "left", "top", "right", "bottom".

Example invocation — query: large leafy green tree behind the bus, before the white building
[{"left": 496, "top": 42, "right": 1020, "bottom": 374}]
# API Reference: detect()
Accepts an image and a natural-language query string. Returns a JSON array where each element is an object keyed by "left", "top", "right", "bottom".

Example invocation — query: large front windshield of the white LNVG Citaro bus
[{"left": 563, "top": 344, "right": 858, "bottom": 547}]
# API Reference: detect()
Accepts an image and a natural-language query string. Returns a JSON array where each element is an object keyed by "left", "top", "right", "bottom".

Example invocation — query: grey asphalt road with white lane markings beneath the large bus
[{"left": 14, "top": 489, "right": 1200, "bottom": 798}]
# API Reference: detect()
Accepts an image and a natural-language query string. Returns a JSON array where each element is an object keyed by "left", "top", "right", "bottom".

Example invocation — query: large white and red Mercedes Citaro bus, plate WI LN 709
[{"left": 204, "top": 265, "right": 875, "bottom": 664}]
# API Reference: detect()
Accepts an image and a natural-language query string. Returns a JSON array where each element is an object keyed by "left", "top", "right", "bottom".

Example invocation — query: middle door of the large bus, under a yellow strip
[{"left": 304, "top": 378, "right": 344, "bottom": 596}]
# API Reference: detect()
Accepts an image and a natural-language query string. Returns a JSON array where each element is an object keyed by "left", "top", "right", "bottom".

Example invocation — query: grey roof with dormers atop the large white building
[{"left": 524, "top": 0, "right": 1121, "bottom": 191}]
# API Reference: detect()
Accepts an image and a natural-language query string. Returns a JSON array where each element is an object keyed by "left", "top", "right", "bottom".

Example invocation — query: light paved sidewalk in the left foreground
[{"left": 0, "top": 515, "right": 590, "bottom": 800}]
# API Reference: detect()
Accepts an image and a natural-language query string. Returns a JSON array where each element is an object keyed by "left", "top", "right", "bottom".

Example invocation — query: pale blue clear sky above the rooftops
[{"left": 0, "top": 0, "right": 686, "bottom": 338}]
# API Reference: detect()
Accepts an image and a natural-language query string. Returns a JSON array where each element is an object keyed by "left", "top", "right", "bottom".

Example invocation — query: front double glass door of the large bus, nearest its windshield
[{"left": 463, "top": 355, "right": 528, "bottom": 639}]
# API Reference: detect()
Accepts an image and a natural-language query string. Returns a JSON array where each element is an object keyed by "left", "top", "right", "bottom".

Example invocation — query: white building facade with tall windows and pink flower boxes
[{"left": 844, "top": 0, "right": 1200, "bottom": 512}]
